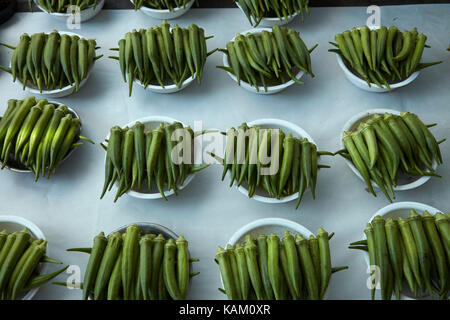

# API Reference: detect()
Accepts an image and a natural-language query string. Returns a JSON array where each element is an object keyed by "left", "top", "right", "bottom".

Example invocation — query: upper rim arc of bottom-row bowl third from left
[{"left": 229, "top": 217, "right": 314, "bottom": 247}]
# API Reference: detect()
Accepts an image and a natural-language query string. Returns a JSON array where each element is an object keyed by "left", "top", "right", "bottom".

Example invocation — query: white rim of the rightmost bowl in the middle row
[{"left": 339, "top": 108, "right": 437, "bottom": 191}]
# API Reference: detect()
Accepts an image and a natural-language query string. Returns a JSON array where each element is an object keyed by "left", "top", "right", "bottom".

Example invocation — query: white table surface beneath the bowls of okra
[{"left": 0, "top": 4, "right": 450, "bottom": 299}]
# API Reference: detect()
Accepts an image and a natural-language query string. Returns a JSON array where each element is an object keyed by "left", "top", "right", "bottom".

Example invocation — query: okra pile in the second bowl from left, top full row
[{"left": 110, "top": 20, "right": 216, "bottom": 96}]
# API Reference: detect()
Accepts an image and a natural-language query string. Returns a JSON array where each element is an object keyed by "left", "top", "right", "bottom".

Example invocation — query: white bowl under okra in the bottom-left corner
[{"left": 0, "top": 216, "right": 47, "bottom": 300}]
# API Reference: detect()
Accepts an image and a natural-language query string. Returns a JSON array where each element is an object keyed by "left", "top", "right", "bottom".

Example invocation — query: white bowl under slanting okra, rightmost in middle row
[{"left": 340, "top": 109, "right": 437, "bottom": 191}]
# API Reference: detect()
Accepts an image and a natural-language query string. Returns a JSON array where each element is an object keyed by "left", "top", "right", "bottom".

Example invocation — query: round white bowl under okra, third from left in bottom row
[{"left": 225, "top": 218, "right": 329, "bottom": 299}]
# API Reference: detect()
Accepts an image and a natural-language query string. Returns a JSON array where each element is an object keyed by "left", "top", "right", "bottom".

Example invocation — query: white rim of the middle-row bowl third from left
[{"left": 228, "top": 118, "right": 317, "bottom": 204}]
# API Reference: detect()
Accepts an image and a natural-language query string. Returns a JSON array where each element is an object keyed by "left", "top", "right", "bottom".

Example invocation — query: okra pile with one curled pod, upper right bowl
[{"left": 329, "top": 26, "right": 442, "bottom": 90}]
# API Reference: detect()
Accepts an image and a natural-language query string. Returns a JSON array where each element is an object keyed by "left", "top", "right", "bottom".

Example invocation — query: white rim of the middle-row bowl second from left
[{"left": 104, "top": 115, "right": 196, "bottom": 200}]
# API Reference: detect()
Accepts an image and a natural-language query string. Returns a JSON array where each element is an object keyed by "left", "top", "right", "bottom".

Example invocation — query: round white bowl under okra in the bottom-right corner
[{"left": 362, "top": 201, "right": 442, "bottom": 300}]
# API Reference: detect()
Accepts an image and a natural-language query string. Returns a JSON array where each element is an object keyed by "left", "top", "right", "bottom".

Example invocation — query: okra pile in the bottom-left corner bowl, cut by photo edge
[{"left": 0, "top": 228, "right": 68, "bottom": 300}]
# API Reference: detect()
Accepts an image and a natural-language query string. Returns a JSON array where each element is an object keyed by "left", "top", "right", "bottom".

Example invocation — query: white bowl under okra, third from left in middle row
[{"left": 228, "top": 119, "right": 316, "bottom": 203}]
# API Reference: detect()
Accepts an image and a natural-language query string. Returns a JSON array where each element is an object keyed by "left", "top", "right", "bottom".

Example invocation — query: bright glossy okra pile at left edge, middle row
[{"left": 0, "top": 97, "right": 93, "bottom": 181}]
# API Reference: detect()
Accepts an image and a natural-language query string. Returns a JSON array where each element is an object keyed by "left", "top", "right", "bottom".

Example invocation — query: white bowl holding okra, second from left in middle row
[{"left": 104, "top": 116, "right": 201, "bottom": 200}]
